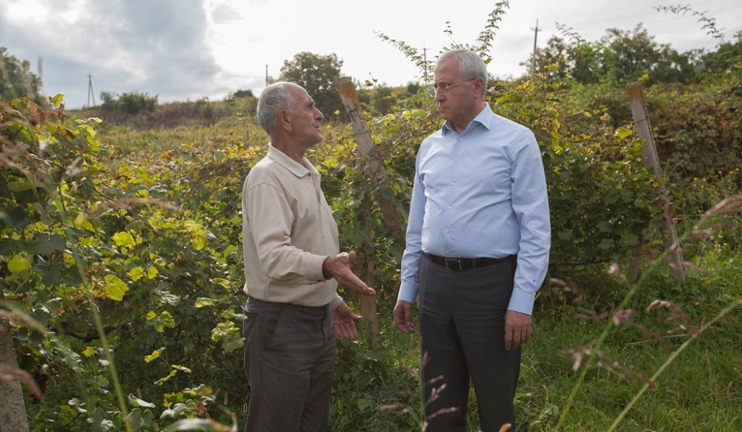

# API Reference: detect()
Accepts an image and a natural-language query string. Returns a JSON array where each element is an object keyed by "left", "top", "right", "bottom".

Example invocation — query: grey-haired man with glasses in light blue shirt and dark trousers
[{"left": 394, "top": 50, "right": 551, "bottom": 432}]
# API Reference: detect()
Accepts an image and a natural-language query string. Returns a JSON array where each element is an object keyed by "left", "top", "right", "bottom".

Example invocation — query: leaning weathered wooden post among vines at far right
[{"left": 626, "top": 83, "right": 685, "bottom": 282}]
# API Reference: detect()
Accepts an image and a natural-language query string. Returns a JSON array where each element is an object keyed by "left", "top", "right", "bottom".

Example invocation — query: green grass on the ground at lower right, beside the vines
[{"left": 366, "top": 250, "right": 742, "bottom": 432}]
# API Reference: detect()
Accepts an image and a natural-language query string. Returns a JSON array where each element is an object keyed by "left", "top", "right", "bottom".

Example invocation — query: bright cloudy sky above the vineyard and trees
[{"left": 0, "top": 0, "right": 742, "bottom": 108}]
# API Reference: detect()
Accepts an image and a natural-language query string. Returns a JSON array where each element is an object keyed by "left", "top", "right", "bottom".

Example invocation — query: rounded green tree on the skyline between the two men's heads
[{"left": 279, "top": 52, "right": 347, "bottom": 119}]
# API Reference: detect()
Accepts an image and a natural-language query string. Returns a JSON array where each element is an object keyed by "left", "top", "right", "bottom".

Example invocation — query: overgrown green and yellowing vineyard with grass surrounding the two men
[{"left": 0, "top": 11, "right": 742, "bottom": 432}]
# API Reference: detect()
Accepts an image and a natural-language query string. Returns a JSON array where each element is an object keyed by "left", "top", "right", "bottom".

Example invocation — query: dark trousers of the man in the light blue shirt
[{"left": 419, "top": 256, "right": 520, "bottom": 432}]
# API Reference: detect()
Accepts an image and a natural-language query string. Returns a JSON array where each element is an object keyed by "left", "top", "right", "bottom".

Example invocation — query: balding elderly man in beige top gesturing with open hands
[{"left": 242, "top": 82, "right": 376, "bottom": 432}]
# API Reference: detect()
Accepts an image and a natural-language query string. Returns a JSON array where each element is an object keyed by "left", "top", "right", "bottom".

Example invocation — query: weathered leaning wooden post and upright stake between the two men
[{"left": 335, "top": 77, "right": 405, "bottom": 347}]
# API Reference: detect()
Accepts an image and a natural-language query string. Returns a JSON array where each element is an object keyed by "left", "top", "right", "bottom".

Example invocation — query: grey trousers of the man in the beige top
[{"left": 242, "top": 298, "right": 335, "bottom": 432}]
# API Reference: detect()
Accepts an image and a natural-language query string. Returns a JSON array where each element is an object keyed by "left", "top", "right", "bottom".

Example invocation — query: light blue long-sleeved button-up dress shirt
[{"left": 397, "top": 104, "right": 551, "bottom": 315}]
